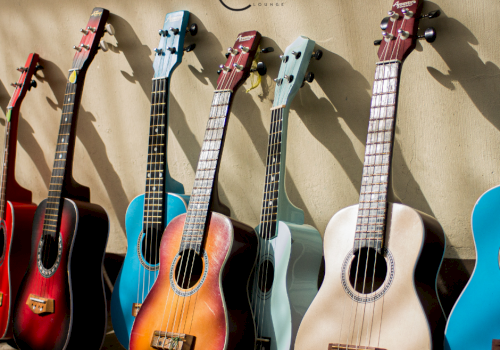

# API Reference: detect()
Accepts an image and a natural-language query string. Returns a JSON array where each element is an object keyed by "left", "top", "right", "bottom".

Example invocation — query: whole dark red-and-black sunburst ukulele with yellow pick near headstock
[{"left": 14, "top": 8, "right": 113, "bottom": 350}]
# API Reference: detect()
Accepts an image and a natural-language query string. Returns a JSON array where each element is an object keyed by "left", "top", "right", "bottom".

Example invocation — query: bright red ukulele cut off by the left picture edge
[{"left": 0, "top": 53, "right": 43, "bottom": 339}]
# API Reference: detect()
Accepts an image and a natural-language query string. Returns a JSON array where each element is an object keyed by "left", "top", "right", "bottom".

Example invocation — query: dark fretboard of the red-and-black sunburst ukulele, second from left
[{"left": 43, "top": 79, "right": 81, "bottom": 237}]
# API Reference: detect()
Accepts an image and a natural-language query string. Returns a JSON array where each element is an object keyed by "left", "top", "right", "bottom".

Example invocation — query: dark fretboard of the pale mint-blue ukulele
[{"left": 259, "top": 107, "right": 283, "bottom": 239}]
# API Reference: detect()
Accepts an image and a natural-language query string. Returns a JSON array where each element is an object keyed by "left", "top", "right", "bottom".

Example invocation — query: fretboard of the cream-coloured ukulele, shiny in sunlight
[{"left": 354, "top": 61, "right": 400, "bottom": 252}]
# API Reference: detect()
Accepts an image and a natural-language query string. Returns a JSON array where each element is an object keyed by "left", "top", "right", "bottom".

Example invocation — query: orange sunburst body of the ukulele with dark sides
[{"left": 130, "top": 212, "right": 257, "bottom": 350}]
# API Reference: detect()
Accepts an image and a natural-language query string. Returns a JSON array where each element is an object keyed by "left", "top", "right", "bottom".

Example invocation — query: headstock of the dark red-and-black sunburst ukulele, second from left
[{"left": 70, "top": 7, "right": 115, "bottom": 83}]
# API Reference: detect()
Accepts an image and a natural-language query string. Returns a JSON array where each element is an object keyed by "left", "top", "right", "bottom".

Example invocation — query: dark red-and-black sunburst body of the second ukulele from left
[{"left": 14, "top": 198, "right": 109, "bottom": 350}]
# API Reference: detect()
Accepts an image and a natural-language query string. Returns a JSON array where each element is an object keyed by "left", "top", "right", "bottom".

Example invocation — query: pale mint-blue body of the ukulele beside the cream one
[{"left": 251, "top": 221, "right": 323, "bottom": 350}]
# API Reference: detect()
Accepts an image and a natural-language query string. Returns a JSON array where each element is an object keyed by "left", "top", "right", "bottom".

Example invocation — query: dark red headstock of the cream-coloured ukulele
[{"left": 375, "top": 0, "right": 440, "bottom": 62}]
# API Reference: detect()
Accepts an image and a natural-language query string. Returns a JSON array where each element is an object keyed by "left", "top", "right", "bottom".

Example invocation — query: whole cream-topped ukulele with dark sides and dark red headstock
[{"left": 295, "top": 0, "right": 445, "bottom": 350}]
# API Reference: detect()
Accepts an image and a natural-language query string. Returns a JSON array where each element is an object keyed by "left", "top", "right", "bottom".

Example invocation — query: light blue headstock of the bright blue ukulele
[{"left": 153, "top": 11, "right": 198, "bottom": 78}]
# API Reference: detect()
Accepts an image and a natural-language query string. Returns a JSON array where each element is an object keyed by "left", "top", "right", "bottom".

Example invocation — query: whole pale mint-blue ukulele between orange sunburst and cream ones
[{"left": 250, "top": 36, "right": 322, "bottom": 350}]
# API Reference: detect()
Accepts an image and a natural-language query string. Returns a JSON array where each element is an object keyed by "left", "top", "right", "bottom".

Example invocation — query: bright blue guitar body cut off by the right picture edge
[{"left": 445, "top": 187, "right": 500, "bottom": 350}]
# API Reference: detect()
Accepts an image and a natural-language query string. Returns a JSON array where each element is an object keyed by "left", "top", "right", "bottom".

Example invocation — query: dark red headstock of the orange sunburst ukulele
[{"left": 217, "top": 30, "right": 271, "bottom": 92}]
